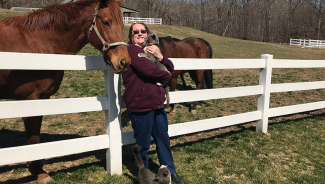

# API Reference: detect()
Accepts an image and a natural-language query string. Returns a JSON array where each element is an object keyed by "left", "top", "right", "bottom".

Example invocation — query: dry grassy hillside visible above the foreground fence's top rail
[{"left": 0, "top": 9, "right": 325, "bottom": 59}]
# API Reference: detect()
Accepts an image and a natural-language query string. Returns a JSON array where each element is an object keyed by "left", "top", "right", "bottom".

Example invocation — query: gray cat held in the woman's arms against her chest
[{"left": 138, "top": 33, "right": 169, "bottom": 107}]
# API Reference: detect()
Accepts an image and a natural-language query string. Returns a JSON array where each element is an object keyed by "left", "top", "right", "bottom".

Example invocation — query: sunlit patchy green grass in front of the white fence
[{"left": 17, "top": 116, "right": 325, "bottom": 184}]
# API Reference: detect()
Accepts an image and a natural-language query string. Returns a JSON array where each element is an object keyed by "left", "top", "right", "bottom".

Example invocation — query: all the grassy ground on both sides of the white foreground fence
[{"left": 0, "top": 9, "right": 325, "bottom": 184}]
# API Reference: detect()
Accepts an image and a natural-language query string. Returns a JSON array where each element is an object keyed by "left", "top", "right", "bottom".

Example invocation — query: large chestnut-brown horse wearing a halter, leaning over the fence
[{"left": 0, "top": 0, "right": 131, "bottom": 183}]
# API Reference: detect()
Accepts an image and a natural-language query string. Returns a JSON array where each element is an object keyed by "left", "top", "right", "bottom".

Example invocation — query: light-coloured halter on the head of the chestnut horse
[{"left": 88, "top": 4, "right": 127, "bottom": 66}]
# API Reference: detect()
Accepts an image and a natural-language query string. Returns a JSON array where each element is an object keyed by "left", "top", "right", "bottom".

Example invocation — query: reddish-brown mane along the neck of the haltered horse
[{"left": 3, "top": 0, "right": 98, "bottom": 31}]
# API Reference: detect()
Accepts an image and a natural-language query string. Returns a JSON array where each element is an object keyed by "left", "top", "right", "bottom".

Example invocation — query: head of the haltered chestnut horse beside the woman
[{"left": 88, "top": 0, "right": 131, "bottom": 74}]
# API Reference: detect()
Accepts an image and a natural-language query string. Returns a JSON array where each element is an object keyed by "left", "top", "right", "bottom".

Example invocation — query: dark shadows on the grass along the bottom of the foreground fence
[{"left": 0, "top": 112, "right": 325, "bottom": 184}]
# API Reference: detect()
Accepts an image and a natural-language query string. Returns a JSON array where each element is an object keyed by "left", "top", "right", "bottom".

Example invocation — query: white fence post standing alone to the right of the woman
[{"left": 256, "top": 54, "right": 273, "bottom": 133}]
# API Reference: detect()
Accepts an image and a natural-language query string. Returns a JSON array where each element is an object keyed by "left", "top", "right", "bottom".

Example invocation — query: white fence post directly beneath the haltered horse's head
[{"left": 105, "top": 67, "right": 122, "bottom": 175}]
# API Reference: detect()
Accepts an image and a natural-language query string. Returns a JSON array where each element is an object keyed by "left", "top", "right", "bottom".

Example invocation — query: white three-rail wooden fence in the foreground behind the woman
[{"left": 0, "top": 52, "right": 325, "bottom": 174}]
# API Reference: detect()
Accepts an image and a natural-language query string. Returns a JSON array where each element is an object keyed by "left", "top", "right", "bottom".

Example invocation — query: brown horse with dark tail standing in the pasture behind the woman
[{"left": 159, "top": 36, "right": 213, "bottom": 113}]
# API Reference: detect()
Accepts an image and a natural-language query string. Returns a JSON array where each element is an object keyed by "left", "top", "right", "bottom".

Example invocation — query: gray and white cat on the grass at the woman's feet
[{"left": 132, "top": 145, "right": 171, "bottom": 184}]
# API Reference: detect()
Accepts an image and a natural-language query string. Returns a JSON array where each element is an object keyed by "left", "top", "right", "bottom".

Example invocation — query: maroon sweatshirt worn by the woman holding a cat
[{"left": 122, "top": 44, "right": 174, "bottom": 112}]
